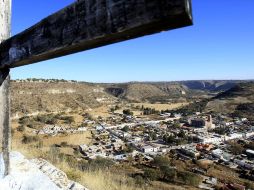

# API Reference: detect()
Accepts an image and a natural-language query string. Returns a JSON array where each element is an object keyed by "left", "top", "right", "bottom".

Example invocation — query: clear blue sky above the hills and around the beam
[{"left": 9, "top": 0, "right": 254, "bottom": 82}]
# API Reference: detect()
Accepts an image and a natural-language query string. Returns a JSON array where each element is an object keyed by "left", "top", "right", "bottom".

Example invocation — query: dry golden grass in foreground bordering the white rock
[{"left": 12, "top": 139, "right": 142, "bottom": 190}]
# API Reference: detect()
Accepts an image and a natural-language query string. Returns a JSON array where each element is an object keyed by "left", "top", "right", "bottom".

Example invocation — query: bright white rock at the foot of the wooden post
[{"left": 0, "top": 152, "right": 88, "bottom": 190}]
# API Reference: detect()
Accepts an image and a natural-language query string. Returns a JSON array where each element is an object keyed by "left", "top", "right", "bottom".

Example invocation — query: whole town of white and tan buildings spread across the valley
[{"left": 23, "top": 106, "right": 254, "bottom": 189}]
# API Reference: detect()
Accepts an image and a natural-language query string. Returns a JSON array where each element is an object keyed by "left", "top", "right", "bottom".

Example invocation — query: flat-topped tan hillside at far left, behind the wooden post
[{"left": 11, "top": 79, "right": 116, "bottom": 115}]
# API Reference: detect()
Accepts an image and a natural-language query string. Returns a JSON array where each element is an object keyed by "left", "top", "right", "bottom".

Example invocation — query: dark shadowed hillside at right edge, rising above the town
[{"left": 206, "top": 82, "right": 254, "bottom": 118}]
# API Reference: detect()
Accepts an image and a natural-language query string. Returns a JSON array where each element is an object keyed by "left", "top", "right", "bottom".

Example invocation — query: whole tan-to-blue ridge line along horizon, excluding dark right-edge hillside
[{"left": 11, "top": 79, "right": 247, "bottom": 116}]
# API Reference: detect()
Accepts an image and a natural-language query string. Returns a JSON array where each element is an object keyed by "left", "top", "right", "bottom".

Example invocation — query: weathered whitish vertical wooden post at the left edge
[{"left": 0, "top": 0, "right": 11, "bottom": 175}]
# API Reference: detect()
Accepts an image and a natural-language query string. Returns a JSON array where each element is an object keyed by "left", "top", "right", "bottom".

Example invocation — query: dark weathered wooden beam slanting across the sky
[{"left": 0, "top": 0, "right": 192, "bottom": 68}]
